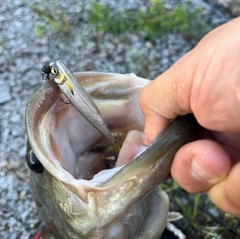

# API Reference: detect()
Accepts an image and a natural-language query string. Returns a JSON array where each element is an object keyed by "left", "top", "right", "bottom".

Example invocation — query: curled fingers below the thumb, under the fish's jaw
[{"left": 171, "top": 140, "right": 240, "bottom": 216}]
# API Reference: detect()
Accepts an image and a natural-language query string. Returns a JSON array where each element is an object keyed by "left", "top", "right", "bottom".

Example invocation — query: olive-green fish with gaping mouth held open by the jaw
[{"left": 26, "top": 72, "right": 197, "bottom": 239}]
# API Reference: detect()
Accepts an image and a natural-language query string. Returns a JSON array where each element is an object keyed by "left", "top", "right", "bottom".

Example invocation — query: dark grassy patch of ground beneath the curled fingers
[{"left": 161, "top": 180, "right": 240, "bottom": 239}]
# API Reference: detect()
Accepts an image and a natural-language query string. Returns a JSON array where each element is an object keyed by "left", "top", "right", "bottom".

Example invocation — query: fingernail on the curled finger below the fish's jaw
[{"left": 191, "top": 157, "right": 215, "bottom": 181}]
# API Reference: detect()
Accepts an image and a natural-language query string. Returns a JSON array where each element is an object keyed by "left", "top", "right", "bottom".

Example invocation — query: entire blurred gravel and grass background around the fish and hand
[{"left": 0, "top": 0, "right": 240, "bottom": 239}]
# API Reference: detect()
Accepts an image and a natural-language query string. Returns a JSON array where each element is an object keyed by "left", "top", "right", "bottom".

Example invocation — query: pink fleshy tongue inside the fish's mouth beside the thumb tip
[{"left": 115, "top": 130, "right": 147, "bottom": 167}]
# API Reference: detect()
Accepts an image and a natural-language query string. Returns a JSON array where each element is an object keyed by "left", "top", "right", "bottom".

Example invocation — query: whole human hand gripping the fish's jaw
[{"left": 139, "top": 18, "right": 240, "bottom": 216}]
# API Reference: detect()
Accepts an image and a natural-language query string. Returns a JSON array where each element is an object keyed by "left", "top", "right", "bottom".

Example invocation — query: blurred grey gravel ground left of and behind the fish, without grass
[{"left": 0, "top": 0, "right": 237, "bottom": 239}]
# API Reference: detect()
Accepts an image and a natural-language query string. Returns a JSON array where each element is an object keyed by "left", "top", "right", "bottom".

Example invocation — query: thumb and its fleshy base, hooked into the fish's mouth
[{"left": 139, "top": 18, "right": 240, "bottom": 144}]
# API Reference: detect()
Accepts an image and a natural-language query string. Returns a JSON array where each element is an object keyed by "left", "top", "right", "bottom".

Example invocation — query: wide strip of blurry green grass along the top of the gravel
[{"left": 89, "top": 0, "right": 209, "bottom": 40}]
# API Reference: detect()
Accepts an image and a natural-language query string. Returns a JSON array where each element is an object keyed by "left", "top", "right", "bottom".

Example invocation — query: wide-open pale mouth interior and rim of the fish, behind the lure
[{"left": 26, "top": 73, "right": 148, "bottom": 191}]
